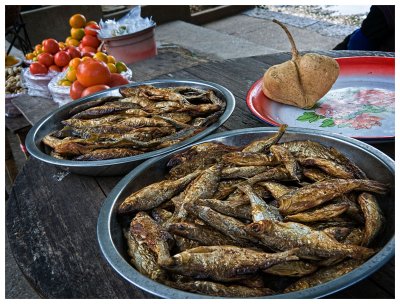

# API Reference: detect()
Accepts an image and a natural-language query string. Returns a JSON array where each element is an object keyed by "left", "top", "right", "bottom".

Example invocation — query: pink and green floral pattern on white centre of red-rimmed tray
[{"left": 297, "top": 87, "right": 395, "bottom": 130}]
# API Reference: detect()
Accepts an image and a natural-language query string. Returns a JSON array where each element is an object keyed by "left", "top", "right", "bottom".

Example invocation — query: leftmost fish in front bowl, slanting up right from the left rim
[{"left": 118, "top": 172, "right": 201, "bottom": 213}]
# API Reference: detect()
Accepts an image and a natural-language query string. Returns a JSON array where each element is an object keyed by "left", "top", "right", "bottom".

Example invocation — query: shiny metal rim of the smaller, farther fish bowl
[{"left": 25, "top": 79, "right": 236, "bottom": 168}]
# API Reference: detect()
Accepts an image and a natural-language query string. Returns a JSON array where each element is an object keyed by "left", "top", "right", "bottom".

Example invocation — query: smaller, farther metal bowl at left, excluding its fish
[{"left": 25, "top": 79, "right": 235, "bottom": 176}]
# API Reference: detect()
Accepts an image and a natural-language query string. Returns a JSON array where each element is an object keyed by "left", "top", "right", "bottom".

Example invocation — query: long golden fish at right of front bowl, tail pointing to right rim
[{"left": 278, "top": 179, "right": 387, "bottom": 215}]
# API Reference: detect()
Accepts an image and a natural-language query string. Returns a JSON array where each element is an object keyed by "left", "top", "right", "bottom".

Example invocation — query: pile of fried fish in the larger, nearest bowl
[{"left": 118, "top": 126, "right": 389, "bottom": 297}]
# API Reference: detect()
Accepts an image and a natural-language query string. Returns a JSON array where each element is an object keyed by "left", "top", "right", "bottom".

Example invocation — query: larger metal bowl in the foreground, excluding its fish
[{"left": 97, "top": 128, "right": 395, "bottom": 298}]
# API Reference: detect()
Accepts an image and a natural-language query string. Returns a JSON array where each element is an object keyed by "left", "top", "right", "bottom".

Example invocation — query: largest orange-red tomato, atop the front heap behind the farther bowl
[{"left": 76, "top": 59, "right": 111, "bottom": 87}]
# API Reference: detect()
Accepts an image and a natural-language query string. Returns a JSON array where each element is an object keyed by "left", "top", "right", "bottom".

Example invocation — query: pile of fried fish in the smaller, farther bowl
[{"left": 42, "top": 85, "right": 226, "bottom": 161}]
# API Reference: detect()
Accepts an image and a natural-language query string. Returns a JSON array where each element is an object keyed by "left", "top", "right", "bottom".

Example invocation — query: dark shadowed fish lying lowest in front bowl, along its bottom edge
[{"left": 165, "top": 280, "right": 275, "bottom": 298}]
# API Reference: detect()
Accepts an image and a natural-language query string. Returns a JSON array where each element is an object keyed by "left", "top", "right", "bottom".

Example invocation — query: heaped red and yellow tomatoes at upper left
[{"left": 26, "top": 14, "right": 129, "bottom": 99}]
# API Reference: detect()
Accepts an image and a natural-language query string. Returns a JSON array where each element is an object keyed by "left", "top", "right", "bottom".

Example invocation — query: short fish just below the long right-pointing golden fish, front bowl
[{"left": 284, "top": 202, "right": 349, "bottom": 223}]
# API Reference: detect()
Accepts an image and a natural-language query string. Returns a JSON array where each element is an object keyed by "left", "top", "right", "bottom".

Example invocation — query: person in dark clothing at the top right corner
[{"left": 333, "top": 5, "right": 395, "bottom": 52}]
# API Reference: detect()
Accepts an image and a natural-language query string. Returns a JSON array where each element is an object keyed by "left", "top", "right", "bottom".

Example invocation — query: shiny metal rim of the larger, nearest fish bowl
[{"left": 97, "top": 127, "right": 395, "bottom": 299}]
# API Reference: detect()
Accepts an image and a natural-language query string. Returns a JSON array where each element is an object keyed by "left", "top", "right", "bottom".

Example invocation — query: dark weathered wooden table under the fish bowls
[{"left": 6, "top": 51, "right": 395, "bottom": 298}]
